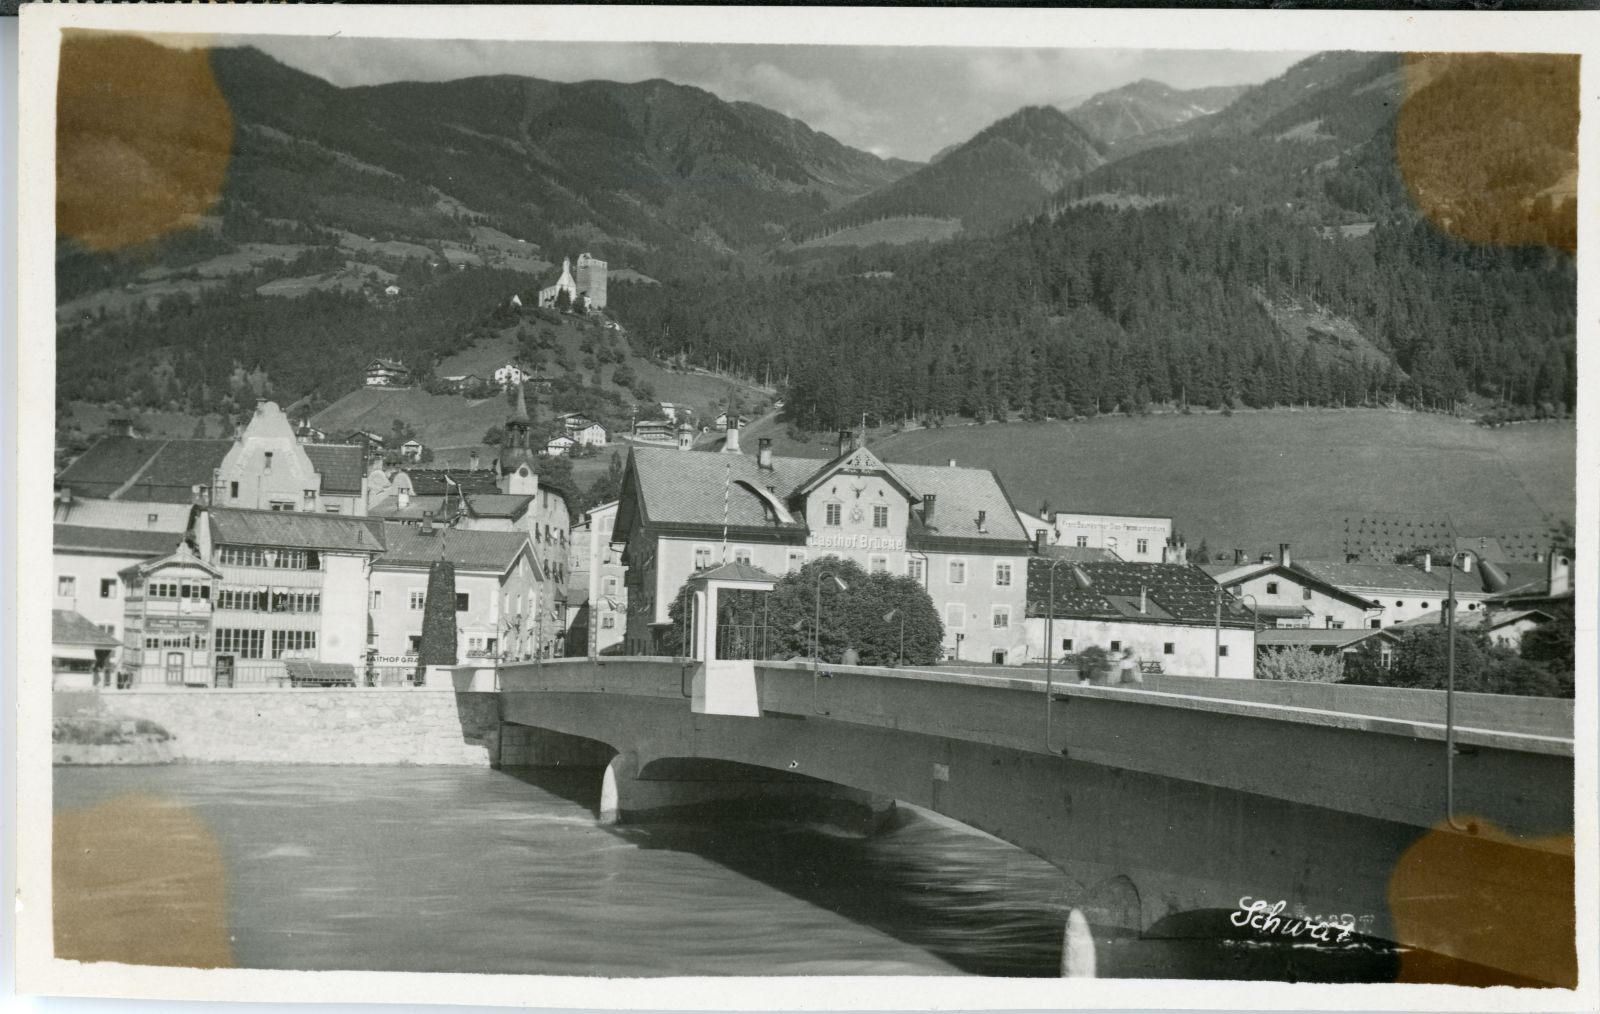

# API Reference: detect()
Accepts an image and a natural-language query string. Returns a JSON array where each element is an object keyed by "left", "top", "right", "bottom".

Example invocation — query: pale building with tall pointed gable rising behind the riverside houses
[{"left": 210, "top": 401, "right": 366, "bottom": 515}]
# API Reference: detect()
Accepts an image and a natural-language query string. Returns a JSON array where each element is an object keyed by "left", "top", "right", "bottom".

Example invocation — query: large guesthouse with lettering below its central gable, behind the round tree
[{"left": 614, "top": 430, "right": 1030, "bottom": 664}]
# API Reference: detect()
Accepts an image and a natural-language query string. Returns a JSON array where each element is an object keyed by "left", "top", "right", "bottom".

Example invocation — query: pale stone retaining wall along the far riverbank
[{"left": 74, "top": 688, "right": 499, "bottom": 766}]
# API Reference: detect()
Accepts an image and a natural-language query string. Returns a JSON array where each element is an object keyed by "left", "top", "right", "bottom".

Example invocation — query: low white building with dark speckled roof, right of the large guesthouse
[{"left": 1027, "top": 555, "right": 1256, "bottom": 680}]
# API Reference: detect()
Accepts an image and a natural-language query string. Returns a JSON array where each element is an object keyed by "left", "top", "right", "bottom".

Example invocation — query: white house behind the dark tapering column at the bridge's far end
[{"left": 368, "top": 523, "right": 541, "bottom": 669}]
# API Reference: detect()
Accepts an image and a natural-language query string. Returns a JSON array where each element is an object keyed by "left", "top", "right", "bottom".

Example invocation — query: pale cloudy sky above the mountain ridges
[{"left": 222, "top": 35, "right": 1309, "bottom": 162}]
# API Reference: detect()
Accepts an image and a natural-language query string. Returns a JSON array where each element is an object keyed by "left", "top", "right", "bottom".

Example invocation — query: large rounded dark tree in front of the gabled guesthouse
[{"left": 666, "top": 557, "right": 944, "bottom": 665}]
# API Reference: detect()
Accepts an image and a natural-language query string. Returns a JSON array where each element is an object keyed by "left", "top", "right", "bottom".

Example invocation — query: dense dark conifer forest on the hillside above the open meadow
[{"left": 613, "top": 206, "right": 1576, "bottom": 429}]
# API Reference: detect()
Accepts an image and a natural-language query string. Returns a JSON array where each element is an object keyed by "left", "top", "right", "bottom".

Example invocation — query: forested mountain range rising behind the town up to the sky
[{"left": 56, "top": 35, "right": 1576, "bottom": 431}]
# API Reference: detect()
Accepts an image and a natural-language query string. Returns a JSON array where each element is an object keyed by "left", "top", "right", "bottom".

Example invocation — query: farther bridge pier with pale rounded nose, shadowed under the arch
[{"left": 600, "top": 750, "right": 894, "bottom": 835}]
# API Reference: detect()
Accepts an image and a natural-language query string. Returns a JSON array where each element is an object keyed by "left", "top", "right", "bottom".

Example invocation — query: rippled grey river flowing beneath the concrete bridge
[{"left": 54, "top": 764, "right": 1497, "bottom": 984}]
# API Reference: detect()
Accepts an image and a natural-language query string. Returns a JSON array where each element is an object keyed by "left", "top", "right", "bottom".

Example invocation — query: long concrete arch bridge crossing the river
[{"left": 456, "top": 657, "right": 1576, "bottom": 984}]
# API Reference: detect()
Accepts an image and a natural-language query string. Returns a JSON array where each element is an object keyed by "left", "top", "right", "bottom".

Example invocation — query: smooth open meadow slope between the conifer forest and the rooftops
[{"left": 844, "top": 411, "right": 1576, "bottom": 558}]
